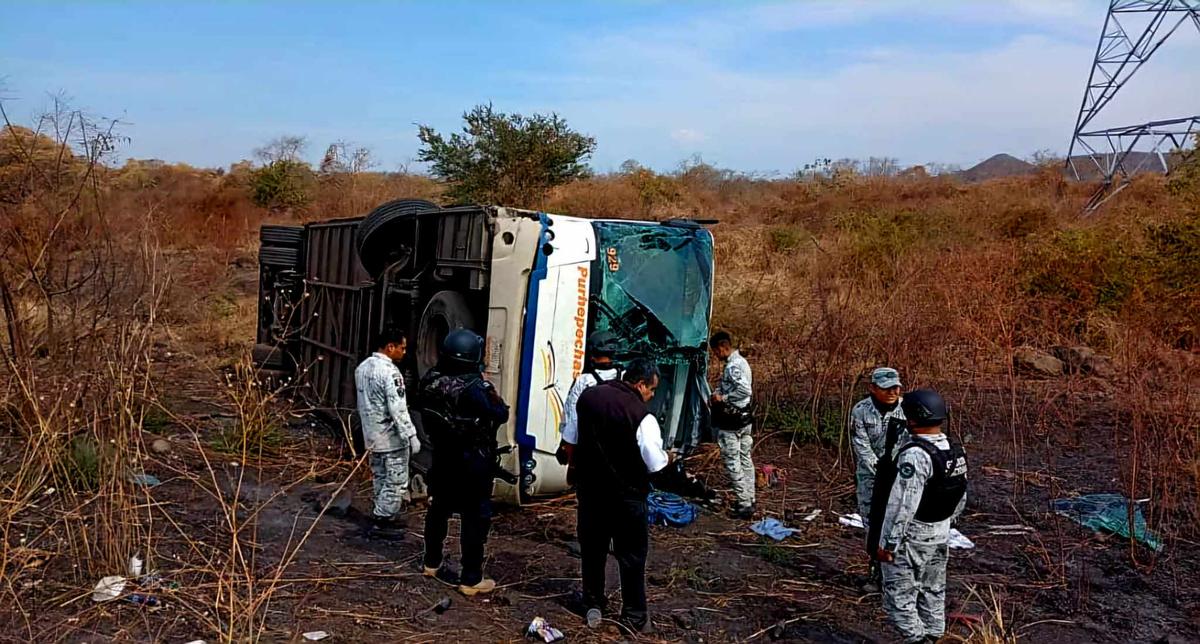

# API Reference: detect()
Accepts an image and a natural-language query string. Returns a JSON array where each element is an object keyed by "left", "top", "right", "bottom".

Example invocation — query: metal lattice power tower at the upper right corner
[{"left": 1067, "top": 0, "right": 1200, "bottom": 211}]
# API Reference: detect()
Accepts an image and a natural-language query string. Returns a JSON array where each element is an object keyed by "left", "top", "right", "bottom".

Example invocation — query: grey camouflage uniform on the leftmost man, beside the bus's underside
[{"left": 354, "top": 353, "right": 416, "bottom": 518}]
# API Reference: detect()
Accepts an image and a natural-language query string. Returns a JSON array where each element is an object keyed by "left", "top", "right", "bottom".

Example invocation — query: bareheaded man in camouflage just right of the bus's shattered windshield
[{"left": 708, "top": 331, "right": 755, "bottom": 518}]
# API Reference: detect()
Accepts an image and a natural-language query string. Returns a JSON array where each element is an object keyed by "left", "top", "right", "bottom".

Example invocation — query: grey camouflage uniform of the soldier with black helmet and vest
[{"left": 880, "top": 434, "right": 966, "bottom": 642}]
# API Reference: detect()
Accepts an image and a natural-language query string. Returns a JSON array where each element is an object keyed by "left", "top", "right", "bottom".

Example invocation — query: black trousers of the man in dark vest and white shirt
[{"left": 578, "top": 489, "right": 650, "bottom": 628}]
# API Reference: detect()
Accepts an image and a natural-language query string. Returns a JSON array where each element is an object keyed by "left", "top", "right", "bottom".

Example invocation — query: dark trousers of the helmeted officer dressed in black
[{"left": 425, "top": 452, "right": 492, "bottom": 585}]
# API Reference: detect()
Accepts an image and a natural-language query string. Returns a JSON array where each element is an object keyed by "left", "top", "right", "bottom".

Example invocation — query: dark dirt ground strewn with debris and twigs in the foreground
[{"left": 7, "top": 350, "right": 1200, "bottom": 643}]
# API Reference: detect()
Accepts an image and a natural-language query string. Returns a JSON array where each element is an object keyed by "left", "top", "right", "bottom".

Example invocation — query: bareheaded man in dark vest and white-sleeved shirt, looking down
[{"left": 575, "top": 359, "right": 670, "bottom": 631}]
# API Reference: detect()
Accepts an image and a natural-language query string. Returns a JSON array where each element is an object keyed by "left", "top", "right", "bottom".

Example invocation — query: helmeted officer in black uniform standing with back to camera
[{"left": 421, "top": 329, "right": 509, "bottom": 596}]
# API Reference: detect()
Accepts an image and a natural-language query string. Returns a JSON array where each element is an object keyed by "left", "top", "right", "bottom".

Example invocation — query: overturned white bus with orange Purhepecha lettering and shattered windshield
[{"left": 254, "top": 199, "right": 713, "bottom": 502}]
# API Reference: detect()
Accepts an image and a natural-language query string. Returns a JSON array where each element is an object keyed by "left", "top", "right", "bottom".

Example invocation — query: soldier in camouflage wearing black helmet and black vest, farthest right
[{"left": 877, "top": 390, "right": 967, "bottom": 643}]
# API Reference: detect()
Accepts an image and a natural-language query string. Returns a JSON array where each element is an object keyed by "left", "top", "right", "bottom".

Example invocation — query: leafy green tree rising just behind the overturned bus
[{"left": 416, "top": 104, "right": 596, "bottom": 206}]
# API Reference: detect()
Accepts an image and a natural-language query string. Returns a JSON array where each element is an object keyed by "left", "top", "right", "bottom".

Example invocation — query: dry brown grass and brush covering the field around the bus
[{"left": 0, "top": 100, "right": 1200, "bottom": 642}]
